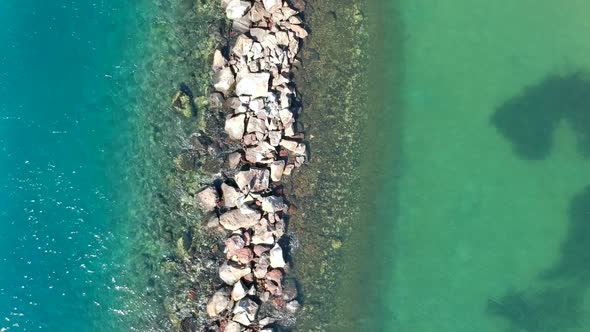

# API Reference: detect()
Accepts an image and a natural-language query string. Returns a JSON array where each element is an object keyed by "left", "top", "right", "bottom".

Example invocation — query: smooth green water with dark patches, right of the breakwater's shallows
[{"left": 372, "top": 0, "right": 590, "bottom": 332}]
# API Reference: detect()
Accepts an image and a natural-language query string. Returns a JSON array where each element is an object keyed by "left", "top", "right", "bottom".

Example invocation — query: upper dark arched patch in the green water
[{"left": 492, "top": 74, "right": 590, "bottom": 160}]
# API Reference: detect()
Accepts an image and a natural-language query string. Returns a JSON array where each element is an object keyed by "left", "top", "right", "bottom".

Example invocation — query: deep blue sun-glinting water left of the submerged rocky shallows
[{"left": 0, "top": 0, "right": 153, "bottom": 331}]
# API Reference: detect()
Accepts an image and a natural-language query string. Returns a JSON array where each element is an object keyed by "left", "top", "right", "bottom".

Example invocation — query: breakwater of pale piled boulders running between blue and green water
[{"left": 199, "top": 0, "right": 307, "bottom": 332}]
